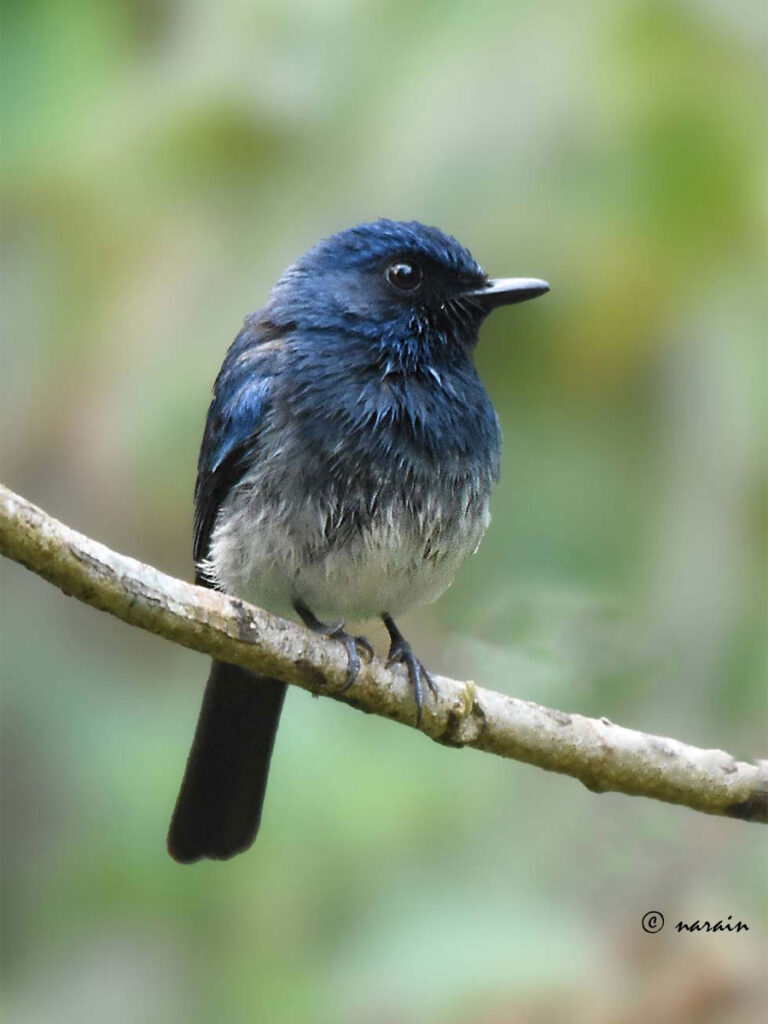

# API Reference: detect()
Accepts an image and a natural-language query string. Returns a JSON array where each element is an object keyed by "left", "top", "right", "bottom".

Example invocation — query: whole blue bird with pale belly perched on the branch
[{"left": 168, "top": 219, "right": 549, "bottom": 863}]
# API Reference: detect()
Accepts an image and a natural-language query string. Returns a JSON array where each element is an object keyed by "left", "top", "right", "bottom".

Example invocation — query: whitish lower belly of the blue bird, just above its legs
[{"left": 209, "top": 486, "right": 490, "bottom": 620}]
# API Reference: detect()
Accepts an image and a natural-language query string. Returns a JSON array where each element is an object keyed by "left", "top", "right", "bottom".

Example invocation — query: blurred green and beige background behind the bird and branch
[{"left": 2, "top": 0, "right": 767, "bottom": 1024}]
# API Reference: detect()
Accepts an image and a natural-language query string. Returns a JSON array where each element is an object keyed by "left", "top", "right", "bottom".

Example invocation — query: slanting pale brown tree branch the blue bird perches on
[{"left": 0, "top": 484, "right": 768, "bottom": 821}]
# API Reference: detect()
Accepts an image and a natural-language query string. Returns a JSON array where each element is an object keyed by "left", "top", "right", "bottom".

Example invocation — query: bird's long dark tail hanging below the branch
[{"left": 168, "top": 662, "right": 286, "bottom": 864}]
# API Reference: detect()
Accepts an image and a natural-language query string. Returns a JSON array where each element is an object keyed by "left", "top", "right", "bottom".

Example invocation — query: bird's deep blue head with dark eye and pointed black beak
[{"left": 268, "top": 220, "right": 549, "bottom": 366}]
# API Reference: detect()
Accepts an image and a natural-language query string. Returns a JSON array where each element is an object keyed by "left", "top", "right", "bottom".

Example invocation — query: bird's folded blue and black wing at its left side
[{"left": 193, "top": 314, "right": 283, "bottom": 586}]
